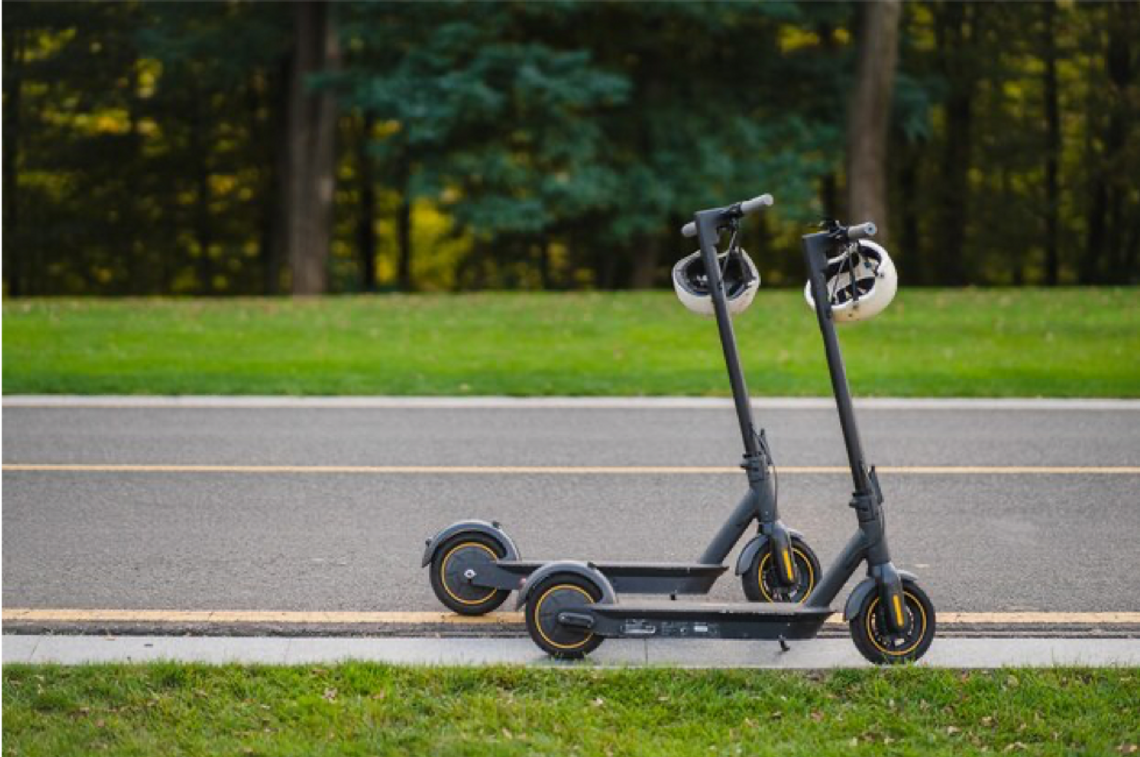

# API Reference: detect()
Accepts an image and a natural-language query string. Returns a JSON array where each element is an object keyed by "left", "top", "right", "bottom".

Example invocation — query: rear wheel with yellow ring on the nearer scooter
[{"left": 526, "top": 573, "right": 604, "bottom": 660}]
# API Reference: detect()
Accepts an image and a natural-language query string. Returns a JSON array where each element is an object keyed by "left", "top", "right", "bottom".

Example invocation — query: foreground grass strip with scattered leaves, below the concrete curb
[{"left": 0, "top": 664, "right": 1140, "bottom": 757}]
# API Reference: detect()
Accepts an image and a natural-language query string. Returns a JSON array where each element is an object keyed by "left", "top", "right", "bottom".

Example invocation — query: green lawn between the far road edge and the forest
[{"left": 0, "top": 288, "right": 1140, "bottom": 397}]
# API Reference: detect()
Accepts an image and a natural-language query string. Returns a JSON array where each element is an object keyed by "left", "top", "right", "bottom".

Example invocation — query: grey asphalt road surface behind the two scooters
[{"left": 0, "top": 399, "right": 1140, "bottom": 611}]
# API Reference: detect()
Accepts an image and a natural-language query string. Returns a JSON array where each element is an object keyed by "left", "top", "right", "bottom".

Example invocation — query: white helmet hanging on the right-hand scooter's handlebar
[{"left": 804, "top": 239, "right": 898, "bottom": 323}]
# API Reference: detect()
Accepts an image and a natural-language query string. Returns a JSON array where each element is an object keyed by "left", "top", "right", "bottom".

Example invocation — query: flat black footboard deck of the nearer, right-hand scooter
[{"left": 559, "top": 602, "right": 833, "bottom": 641}]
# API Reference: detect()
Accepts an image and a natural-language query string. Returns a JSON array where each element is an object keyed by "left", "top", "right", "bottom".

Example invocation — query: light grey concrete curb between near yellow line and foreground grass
[{"left": 0, "top": 636, "right": 1140, "bottom": 669}]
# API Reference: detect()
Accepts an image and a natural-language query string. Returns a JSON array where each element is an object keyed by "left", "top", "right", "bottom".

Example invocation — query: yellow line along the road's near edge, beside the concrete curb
[{"left": 0, "top": 608, "right": 1140, "bottom": 626}]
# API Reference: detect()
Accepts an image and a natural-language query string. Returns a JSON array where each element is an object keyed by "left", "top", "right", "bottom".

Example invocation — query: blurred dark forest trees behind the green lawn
[{"left": 0, "top": 0, "right": 1140, "bottom": 296}]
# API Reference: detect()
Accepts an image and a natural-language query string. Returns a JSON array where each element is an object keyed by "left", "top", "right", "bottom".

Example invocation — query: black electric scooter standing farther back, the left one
[{"left": 423, "top": 195, "right": 821, "bottom": 614}]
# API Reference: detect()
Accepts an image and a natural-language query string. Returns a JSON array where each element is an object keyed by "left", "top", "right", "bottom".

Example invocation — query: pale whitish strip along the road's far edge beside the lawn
[{"left": 0, "top": 394, "right": 1140, "bottom": 412}]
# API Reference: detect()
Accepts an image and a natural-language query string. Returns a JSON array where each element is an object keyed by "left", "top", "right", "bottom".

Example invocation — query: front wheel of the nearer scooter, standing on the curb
[{"left": 848, "top": 580, "right": 937, "bottom": 665}]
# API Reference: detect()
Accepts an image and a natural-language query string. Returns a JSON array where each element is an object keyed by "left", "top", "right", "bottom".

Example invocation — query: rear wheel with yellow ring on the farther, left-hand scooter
[{"left": 431, "top": 531, "right": 511, "bottom": 616}]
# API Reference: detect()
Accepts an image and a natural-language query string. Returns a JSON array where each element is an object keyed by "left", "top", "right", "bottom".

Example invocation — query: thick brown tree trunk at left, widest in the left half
[{"left": 285, "top": 0, "right": 339, "bottom": 294}]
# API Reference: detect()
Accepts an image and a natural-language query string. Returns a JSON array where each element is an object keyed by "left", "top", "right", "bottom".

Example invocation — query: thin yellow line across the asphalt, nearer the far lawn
[{"left": 0, "top": 463, "right": 1140, "bottom": 475}]
